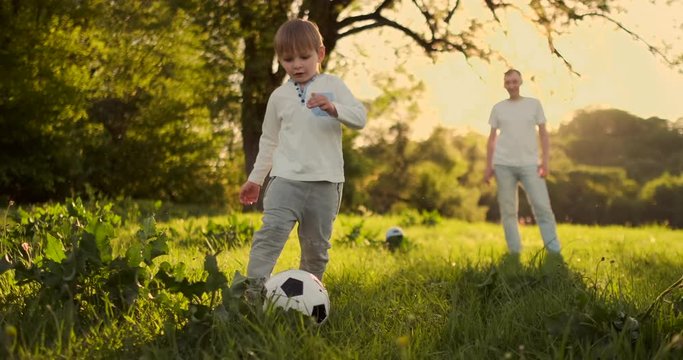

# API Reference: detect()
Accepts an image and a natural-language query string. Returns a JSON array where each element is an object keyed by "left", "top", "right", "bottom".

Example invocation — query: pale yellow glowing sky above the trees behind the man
[{"left": 337, "top": 0, "right": 683, "bottom": 138}]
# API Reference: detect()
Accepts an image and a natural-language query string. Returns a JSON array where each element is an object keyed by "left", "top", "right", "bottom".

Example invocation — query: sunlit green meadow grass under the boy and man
[{"left": 0, "top": 214, "right": 683, "bottom": 359}]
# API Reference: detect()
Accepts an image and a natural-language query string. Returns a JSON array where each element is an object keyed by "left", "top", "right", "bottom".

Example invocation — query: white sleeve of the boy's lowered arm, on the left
[{"left": 248, "top": 95, "right": 280, "bottom": 185}]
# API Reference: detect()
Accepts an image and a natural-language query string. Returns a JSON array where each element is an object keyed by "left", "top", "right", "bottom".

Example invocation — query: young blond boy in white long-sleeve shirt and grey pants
[{"left": 240, "top": 19, "right": 366, "bottom": 298}]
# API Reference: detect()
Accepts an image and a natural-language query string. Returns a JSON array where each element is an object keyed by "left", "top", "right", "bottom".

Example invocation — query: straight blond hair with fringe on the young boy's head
[{"left": 275, "top": 19, "right": 323, "bottom": 58}]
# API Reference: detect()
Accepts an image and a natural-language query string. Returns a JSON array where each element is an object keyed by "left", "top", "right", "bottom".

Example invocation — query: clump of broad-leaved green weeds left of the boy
[{"left": 0, "top": 199, "right": 253, "bottom": 354}]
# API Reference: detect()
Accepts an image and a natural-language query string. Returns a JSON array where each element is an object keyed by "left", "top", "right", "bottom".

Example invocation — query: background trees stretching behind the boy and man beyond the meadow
[{"left": 0, "top": 0, "right": 683, "bottom": 227}]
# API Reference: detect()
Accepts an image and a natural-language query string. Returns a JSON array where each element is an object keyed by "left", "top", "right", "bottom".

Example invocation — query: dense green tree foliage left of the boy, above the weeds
[{"left": 0, "top": 1, "right": 242, "bottom": 202}]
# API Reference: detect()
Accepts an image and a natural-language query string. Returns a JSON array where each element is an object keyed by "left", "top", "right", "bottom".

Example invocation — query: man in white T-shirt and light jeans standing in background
[{"left": 484, "top": 69, "right": 560, "bottom": 256}]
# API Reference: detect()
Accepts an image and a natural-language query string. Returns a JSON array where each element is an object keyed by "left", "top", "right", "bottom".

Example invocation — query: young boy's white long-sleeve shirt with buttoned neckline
[{"left": 249, "top": 74, "right": 367, "bottom": 185}]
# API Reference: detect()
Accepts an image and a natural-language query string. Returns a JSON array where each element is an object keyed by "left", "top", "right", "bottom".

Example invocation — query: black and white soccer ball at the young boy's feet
[{"left": 265, "top": 270, "right": 330, "bottom": 324}]
